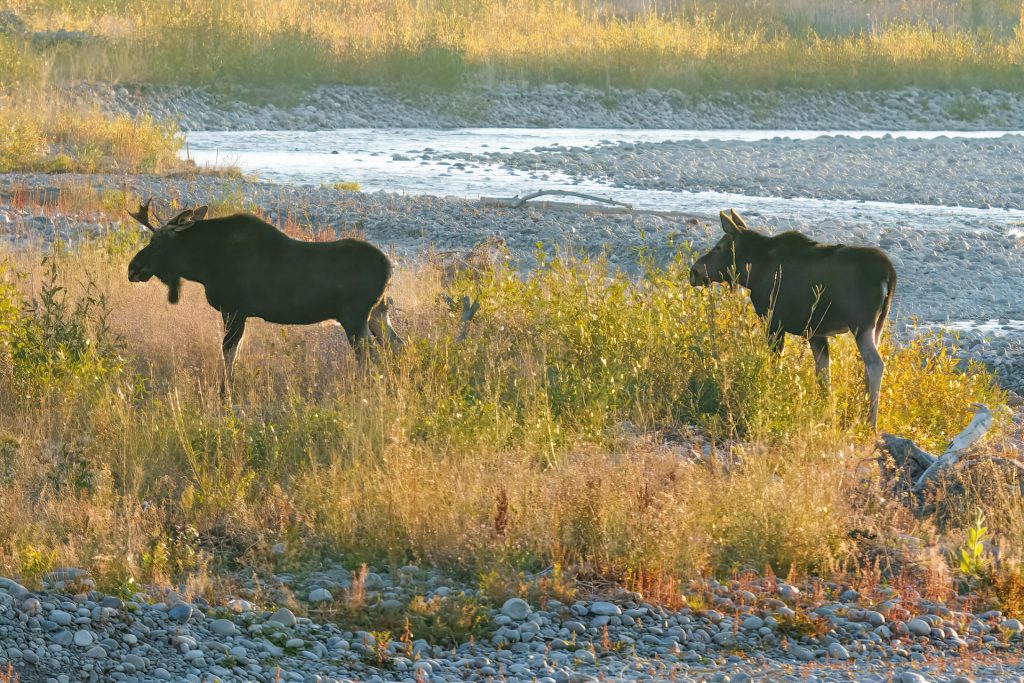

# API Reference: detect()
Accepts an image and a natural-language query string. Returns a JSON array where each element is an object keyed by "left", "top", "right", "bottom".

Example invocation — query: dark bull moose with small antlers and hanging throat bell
[{"left": 128, "top": 198, "right": 400, "bottom": 393}]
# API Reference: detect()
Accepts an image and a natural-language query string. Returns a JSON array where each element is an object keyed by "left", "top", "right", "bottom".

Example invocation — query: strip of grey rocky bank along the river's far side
[{"left": 74, "top": 83, "right": 1024, "bottom": 131}]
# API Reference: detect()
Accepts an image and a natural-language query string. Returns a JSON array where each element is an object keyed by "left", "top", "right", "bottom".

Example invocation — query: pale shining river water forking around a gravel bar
[{"left": 186, "top": 128, "right": 1024, "bottom": 234}]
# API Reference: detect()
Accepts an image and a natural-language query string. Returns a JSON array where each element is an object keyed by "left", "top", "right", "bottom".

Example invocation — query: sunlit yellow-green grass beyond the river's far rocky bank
[{"left": 6, "top": 0, "right": 1024, "bottom": 93}]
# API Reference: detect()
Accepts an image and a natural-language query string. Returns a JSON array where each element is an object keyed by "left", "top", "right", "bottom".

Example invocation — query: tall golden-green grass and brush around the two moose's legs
[{"left": 0, "top": 232, "right": 1007, "bottom": 593}]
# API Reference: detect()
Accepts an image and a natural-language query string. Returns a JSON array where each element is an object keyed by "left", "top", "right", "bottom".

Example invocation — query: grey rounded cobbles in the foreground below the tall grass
[{"left": 0, "top": 564, "right": 1022, "bottom": 683}]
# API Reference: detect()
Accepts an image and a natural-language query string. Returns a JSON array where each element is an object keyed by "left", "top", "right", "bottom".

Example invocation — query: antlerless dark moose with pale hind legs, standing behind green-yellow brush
[{"left": 690, "top": 209, "right": 896, "bottom": 427}]
